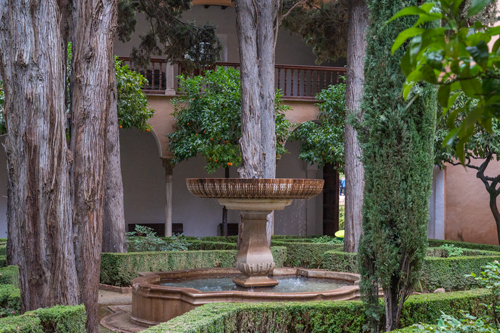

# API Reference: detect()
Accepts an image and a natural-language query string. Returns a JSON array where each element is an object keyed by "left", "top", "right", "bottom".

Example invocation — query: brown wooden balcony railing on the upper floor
[{"left": 119, "top": 57, "right": 346, "bottom": 101}]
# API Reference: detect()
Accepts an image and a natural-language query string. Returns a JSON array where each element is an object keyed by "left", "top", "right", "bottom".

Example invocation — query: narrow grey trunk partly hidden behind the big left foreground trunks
[{"left": 102, "top": 75, "right": 127, "bottom": 252}]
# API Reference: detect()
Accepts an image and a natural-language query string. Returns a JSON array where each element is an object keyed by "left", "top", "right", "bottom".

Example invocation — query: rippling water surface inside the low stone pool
[{"left": 161, "top": 276, "right": 351, "bottom": 293}]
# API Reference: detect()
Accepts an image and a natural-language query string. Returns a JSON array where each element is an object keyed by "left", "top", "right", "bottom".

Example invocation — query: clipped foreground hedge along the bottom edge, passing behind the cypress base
[{"left": 143, "top": 289, "right": 492, "bottom": 333}]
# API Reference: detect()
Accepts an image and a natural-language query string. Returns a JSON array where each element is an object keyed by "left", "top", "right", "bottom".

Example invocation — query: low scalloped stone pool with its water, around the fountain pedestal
[{"left": 131, "top": 268, "right": 360, "bottom": 326}]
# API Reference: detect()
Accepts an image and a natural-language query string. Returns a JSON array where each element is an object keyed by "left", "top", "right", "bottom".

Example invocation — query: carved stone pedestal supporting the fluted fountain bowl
[{"left": 219, "top": 199, "right": 292, "bottom": 288}]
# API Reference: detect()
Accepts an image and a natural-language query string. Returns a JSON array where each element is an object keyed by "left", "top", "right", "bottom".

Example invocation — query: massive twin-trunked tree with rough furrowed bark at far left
[{"left": 0, "top": 0, "right": 116, "bottom": 332}]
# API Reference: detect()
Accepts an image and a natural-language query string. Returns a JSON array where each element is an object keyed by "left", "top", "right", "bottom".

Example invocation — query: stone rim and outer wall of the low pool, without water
[{"left": 131, "top": 268, "right": 360, "bottom": 326}]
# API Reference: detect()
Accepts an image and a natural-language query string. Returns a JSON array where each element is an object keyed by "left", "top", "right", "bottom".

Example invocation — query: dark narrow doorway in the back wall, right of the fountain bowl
[{"left": 323, "top": 164, "right": 339, "bottom": 236}]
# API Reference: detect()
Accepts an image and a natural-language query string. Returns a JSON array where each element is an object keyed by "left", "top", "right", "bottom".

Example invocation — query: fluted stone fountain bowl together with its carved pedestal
[{"left": 186, "top": 178, "right": 324, "bottom": 288}]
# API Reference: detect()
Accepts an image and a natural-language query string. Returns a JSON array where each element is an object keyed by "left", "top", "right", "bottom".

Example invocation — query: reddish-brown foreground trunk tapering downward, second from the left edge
[{"left": 71, "top": 0, "right": 117, "bottom": 333}]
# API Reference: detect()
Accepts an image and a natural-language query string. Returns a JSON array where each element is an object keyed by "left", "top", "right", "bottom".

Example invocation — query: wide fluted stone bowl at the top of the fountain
[{"left": 186, "top": 178, "right": 324, "bottom": 199}]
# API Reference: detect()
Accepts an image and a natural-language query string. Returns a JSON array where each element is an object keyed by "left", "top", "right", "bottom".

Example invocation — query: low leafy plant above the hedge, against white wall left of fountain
[{"left": 126, "top": 225, "right": 190, "bottom": 252}]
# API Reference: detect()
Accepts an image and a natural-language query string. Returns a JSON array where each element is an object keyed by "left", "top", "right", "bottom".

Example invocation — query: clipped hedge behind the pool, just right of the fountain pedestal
[{"left": 272, "top": 240, "right": 343, "bottom": 268}]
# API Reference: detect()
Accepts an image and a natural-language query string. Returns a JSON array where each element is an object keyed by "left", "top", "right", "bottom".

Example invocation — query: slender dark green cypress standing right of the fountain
[{"left": 358, "top": 0, "right": 437, "bottom": 332}]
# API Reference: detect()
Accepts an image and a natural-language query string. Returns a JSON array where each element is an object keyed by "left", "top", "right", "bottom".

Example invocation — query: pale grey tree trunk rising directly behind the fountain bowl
[{"left": 235, "top": 0, "right": 280, "bottom": 244}]
